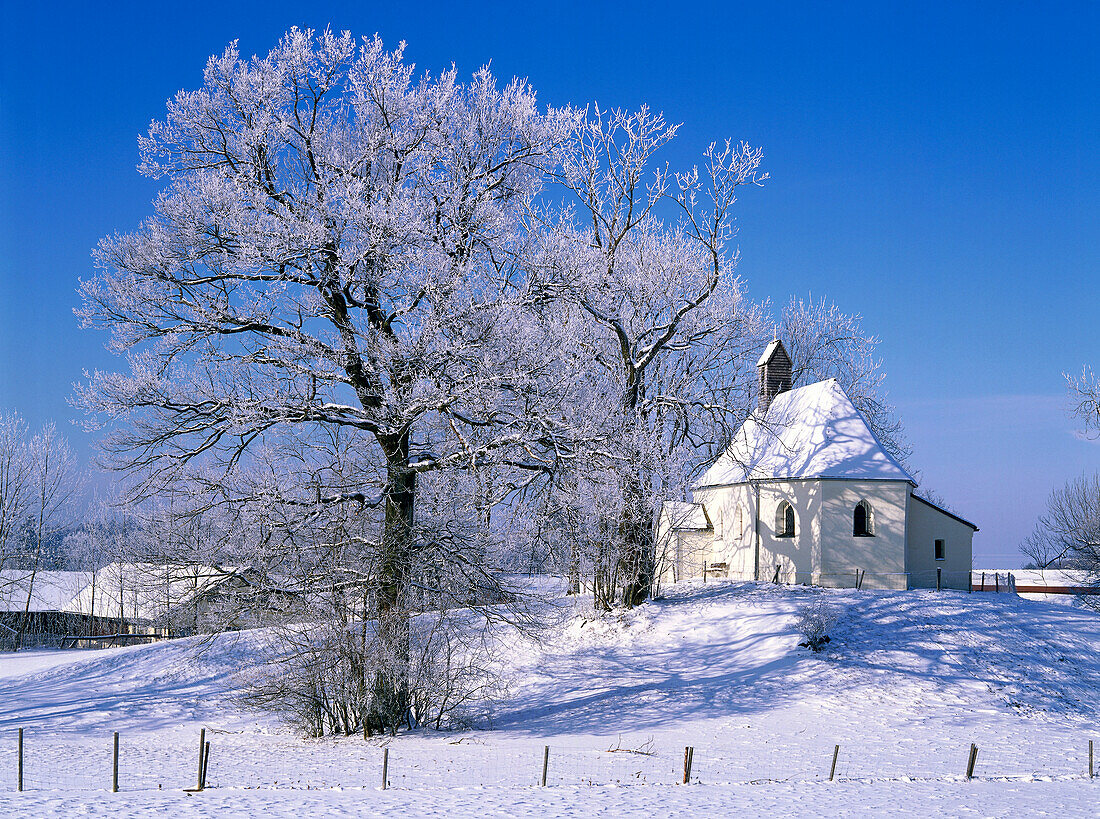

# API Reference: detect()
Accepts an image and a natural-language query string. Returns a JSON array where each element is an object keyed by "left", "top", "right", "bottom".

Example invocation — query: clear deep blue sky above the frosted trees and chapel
[{"left": 0, "top": 1, "right": 1100, "bottom": 567}]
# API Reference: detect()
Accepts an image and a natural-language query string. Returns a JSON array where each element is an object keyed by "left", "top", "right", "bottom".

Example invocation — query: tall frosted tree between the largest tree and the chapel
[{"left": 539, "top": 108, "right": 767, "bottom": 607}]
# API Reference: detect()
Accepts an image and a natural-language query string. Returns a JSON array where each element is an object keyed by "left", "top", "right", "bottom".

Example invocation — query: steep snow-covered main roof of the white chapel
[{"left": 693, "top": 380, "right": 916, "bottom": 489}]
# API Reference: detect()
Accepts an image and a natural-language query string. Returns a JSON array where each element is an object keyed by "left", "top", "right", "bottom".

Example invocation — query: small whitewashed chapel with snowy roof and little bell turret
[{"left": 658, "top": 341, "right": 978, "bottom": 589}]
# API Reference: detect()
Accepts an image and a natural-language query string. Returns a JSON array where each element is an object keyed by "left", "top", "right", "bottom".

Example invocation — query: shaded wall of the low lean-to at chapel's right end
[{"left": 905, "top": 492, "right": 974, "bottom": 589}]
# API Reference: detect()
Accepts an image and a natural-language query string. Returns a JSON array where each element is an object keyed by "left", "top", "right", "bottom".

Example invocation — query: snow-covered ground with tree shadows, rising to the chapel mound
[{"left": 0, "top": 583, "right": 1100, "bottom": 817}]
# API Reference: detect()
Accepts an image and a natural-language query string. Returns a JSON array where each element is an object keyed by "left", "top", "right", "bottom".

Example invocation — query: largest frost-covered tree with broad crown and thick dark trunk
[{"left": 79, "top": 29, "right": 574, "bottom": 724}]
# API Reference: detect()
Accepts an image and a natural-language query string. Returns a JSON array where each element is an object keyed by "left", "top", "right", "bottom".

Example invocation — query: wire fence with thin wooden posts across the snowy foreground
[{"left": 0, "top": 731, "right": 1097, "bottom": 792}]
